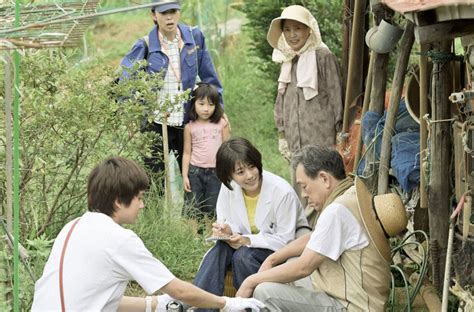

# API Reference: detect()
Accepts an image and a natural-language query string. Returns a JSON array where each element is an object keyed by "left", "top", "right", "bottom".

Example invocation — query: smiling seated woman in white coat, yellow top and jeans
[{"left": 194, "top": 138, "right": 308, "bottom": 310}]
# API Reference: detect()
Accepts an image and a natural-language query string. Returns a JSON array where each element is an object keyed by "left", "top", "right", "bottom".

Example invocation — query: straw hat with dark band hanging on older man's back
[{"left": 355, "top": 177, "right": 408, "bottom": 263}]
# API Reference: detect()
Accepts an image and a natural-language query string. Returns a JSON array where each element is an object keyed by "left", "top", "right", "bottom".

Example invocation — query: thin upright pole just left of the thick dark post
[{"left": 419, "top": 44, "right": 428, "bottom": 208}]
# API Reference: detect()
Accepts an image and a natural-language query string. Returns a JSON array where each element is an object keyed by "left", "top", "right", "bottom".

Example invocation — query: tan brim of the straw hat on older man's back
[{"left": 355, "top": 177, "right": 391, "bottom": 263}]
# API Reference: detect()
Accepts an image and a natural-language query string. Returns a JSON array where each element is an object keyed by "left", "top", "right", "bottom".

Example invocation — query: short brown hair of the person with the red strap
[{"left": 87, "top": 157, "right": 149, "bottom": 216}]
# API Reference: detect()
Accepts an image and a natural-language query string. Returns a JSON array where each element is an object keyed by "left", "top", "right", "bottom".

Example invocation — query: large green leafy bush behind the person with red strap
[{"left": 0, "top": 51, "right": 187, "bottom": 239}]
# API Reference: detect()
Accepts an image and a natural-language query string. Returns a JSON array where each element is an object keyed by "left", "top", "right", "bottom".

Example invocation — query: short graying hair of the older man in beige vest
[{"left": 291, "top": 145, "right": 346, "bottom": 180}]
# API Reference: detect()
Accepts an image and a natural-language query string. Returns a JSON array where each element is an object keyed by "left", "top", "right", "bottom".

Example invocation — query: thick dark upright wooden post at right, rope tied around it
[{"left": 428, "top": 40, "right": 452, "bottom": 291}]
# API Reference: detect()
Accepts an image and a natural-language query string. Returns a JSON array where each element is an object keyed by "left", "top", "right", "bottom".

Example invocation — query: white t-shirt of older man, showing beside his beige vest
[{"left": 306, "top": 203, "right": 369, "bottom": 261}]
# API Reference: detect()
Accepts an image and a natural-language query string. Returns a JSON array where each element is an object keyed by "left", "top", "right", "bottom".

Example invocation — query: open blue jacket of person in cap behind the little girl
[{"left": 120, "top": 24, "right": 224, "bottom": 123}]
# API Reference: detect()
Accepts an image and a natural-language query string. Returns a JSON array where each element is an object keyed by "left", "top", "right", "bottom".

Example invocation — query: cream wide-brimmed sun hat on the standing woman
[{"left": 267, "top": 5, "right": 321, "bottom": 49}]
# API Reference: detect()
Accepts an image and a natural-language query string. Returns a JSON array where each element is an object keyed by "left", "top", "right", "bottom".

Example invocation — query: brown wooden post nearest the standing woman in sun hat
[{"left": 342, "top": 0, "right": 366, "bottom": 137}]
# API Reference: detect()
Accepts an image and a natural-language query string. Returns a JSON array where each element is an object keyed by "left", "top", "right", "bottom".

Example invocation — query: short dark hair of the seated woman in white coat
[{"left": 216, "top": 137, "right": 262, "bottom": 190}]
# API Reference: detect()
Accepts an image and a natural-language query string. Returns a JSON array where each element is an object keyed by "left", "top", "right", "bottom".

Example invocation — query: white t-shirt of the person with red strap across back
[{"left": 32, "top": 212, "right": 175, "bottom": 311}]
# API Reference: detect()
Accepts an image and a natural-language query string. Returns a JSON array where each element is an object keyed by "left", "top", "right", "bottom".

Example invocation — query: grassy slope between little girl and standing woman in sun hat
[{"left": 218, "top": 33, "right": 290, "bottom": 181}]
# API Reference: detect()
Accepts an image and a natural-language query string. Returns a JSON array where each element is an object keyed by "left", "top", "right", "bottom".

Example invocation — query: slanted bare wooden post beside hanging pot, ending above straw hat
[{"left": 378, "top": 20, "right": 415, "bottom": 194}]
